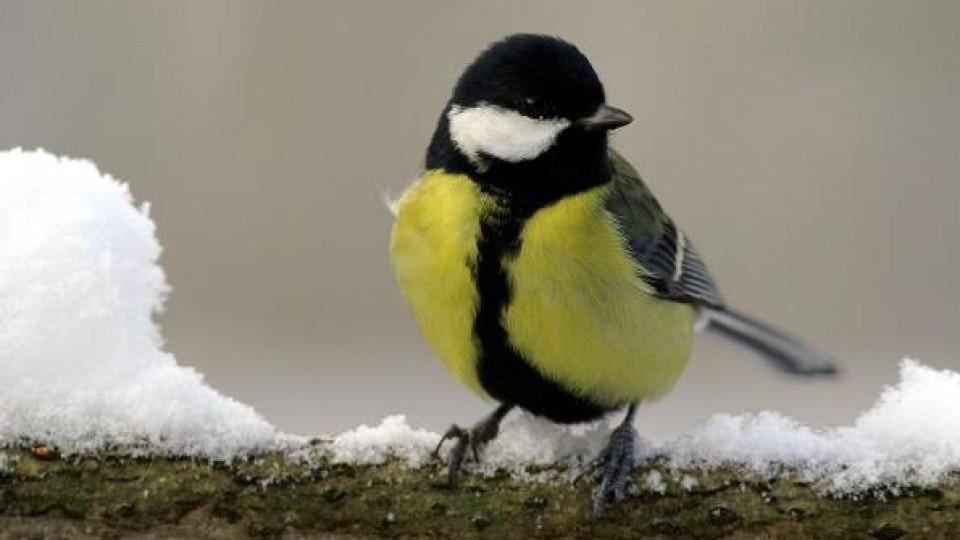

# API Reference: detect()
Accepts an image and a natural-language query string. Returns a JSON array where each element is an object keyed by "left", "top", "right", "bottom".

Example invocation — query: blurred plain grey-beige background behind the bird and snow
[{"left": 0, "top": 0, "right": 960, "bottom": 438}]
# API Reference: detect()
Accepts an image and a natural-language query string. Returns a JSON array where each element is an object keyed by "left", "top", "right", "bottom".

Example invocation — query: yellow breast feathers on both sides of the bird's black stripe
[{"left": 391, "top": 171, "right": 694, "bottom": 404}]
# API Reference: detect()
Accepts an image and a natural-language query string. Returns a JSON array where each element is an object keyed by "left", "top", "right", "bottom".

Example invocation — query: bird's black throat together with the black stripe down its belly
[{"left": 427, "top": 119, "right": 613, "bottom": 423}]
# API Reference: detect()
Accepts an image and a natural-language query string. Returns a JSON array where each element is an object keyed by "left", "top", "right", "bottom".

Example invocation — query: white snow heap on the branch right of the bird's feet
[{"left": 662, "top": 359, "right": 960, "bottom": 493}]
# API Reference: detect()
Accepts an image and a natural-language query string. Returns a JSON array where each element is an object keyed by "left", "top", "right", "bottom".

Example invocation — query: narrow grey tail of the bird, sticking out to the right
[{"left": 702, "top": 308, "right": 837, "bottom": 375}]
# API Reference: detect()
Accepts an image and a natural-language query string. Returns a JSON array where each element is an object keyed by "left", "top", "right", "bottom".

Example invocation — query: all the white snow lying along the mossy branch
[{"left": 0, "top": 150, "right": 960, "bottom": 492}]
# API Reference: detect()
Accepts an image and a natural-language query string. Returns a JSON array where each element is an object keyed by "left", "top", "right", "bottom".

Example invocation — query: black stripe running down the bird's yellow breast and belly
[{"left": 473, "top": 201, "right": 616, "bottom": 423}]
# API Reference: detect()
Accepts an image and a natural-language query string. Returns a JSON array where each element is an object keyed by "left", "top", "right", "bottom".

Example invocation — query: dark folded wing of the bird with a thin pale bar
[{"left": 606, "top": 150, "right": 723, "bottom": 307}]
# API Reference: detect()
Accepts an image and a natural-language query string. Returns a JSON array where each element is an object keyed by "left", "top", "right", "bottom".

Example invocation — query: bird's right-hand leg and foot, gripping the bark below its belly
[{"left": 593, "top": 403, "right": 640, "bottom": 516}]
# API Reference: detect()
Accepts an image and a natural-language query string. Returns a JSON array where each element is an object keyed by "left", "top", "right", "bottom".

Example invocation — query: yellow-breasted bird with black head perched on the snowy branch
[{"left": 390, "top": 34, "right": 837, "bottom": 514}]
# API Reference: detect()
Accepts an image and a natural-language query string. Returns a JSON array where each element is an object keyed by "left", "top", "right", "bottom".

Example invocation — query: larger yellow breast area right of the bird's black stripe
[{"left": 504, "top": 187, "right": 694, "bottom": 404}]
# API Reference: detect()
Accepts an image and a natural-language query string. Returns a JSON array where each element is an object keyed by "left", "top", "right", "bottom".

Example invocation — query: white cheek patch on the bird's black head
[{"left": 447, "top": 105, "right": 570, "bottom": 163}]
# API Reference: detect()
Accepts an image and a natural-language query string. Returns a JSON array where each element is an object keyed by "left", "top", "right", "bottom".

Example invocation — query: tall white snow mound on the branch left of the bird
[{"left": 0, "top": 149, "right": 293, "bottom": 457}]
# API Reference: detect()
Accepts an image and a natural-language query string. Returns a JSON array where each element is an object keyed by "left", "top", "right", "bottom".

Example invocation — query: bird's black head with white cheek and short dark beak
[{"left": 427, "top": 34, "right": 632, "bottom": 207}]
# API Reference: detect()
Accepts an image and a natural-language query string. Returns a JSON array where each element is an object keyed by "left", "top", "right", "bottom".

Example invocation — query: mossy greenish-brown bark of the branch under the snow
[{"left": 0, "top": 450, "right": 960, "bottom": 539}]
